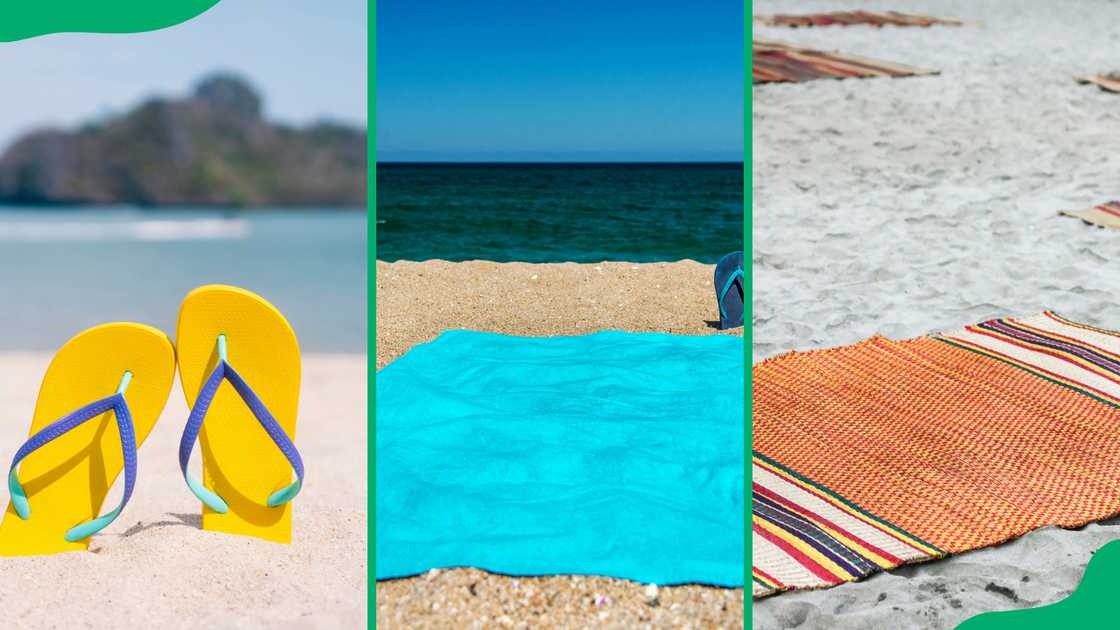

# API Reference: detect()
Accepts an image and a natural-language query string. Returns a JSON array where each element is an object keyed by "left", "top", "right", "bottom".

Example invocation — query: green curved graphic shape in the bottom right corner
[{"left": 956, "top": 533, "right": 1120, "bottom": 630}]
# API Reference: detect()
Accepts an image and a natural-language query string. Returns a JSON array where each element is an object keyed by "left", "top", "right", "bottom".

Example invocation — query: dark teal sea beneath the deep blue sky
[{"left": 376, "top": 163, "right": 743, "bottom": 263}]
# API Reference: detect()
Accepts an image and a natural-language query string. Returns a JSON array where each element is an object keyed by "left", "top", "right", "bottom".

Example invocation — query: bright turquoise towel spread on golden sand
[{"left": 375, "top": 331, "right": 745, "bottom": 586}]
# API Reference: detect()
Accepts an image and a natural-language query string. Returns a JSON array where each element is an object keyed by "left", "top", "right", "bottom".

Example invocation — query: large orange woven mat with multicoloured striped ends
[{"left": 752, "top": 312, "right": 1120, "bottom": 597}]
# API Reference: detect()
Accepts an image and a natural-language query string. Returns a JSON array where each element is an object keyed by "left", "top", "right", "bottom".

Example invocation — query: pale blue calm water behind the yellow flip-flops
[{"left": 0, "top": 206, "right": 367, "bottom": 353}]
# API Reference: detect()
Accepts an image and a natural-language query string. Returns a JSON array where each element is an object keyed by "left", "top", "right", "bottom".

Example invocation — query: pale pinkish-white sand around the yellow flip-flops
[{"left": 0, "top": 353, "right": 367, "bottom": 629}]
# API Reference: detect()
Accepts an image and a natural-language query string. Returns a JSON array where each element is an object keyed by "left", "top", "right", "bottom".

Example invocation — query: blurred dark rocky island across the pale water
[{"left": 0, "top": 74, "right": 366, "bottom": 207}]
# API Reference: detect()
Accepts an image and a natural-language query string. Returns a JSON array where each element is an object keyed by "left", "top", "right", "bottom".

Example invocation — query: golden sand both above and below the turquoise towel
[{"left": 376, "top": 260, "right": 744, "bottom": 629}]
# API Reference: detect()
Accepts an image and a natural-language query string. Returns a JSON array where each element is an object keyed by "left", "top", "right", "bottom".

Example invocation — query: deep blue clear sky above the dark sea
[{"left": 376, "top": 0, "right": 744, "bottom": 161}]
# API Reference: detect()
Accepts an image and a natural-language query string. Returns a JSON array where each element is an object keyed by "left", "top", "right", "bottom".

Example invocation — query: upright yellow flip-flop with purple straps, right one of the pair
[{"left": 176, "top": 285, "right": 304, "bottom": 543}]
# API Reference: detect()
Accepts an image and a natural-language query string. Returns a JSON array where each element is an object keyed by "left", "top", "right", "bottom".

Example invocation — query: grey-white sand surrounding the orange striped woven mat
[{"left": 752, "top": 0, "right": 1120, "bottom": 628}]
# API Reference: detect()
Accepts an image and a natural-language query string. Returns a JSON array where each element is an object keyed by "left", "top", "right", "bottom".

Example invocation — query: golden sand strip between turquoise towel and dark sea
[{"left": 376, "top": 260, "right": 743, "bottom": 369}]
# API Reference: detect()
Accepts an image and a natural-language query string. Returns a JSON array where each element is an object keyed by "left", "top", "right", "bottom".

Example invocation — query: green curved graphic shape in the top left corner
[{"left": 0, "top": 0, "right": 220, "bottom": 41}]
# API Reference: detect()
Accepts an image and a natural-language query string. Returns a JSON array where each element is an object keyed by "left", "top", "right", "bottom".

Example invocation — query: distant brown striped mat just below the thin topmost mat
[{"left": 752, "top": 39, "right": 937, "bottom": 83}]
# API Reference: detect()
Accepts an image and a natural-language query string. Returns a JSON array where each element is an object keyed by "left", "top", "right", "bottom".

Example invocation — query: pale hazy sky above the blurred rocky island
[{"left": 0, "top": 0, "right": 367, "bottom": 151}]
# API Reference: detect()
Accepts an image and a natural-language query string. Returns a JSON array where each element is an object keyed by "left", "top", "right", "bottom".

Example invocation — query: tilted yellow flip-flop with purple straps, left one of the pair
[{"left": 0, "top": 323, "right": 175, "bottom": 556}]
